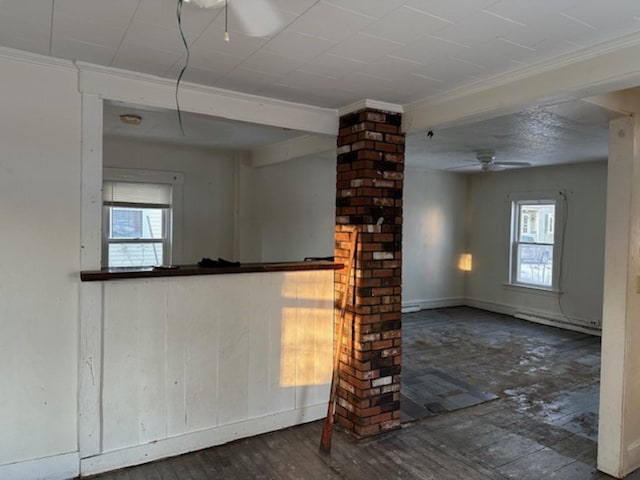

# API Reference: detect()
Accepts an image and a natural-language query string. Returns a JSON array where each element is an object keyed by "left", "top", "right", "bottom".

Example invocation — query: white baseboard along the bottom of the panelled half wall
[{"left": 81, "top": 404, "right": 327, "bottom": 474}]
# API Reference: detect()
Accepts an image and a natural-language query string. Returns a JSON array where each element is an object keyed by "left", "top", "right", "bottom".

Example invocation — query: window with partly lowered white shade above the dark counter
[{"left": 102, "top": 169, "right": 178, "bottom": 267}]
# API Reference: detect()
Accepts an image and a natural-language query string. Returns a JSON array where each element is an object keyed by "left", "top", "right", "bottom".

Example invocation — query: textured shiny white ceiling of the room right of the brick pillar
[{"left": 406, "top": 100, "right": 620, "bottom": 173}]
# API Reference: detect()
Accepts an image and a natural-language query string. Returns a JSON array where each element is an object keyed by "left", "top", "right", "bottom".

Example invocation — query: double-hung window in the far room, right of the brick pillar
[{"left": 509, "top": 194, "right": 560, "bottom": 289}]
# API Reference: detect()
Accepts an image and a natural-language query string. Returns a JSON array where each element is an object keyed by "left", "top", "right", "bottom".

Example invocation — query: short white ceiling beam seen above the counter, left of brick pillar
[{"left": 251, "top": 135, "right": 336, "bottom": 167}]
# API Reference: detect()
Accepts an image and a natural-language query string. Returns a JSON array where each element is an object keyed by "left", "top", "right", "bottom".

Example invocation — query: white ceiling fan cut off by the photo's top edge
[{"left": 184, "top": 0, "right": 284, "bottom": 37}]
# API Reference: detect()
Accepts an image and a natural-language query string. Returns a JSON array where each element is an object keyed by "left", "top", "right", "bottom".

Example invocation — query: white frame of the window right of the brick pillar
[{"left": 507, "top": 190, "right": 564, "bottom": 292}]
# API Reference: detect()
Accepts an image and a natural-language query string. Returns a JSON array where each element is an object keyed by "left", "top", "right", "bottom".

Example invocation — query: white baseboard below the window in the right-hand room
[{"left": 466, "top": 298, "right": 602, "bottom": 335}]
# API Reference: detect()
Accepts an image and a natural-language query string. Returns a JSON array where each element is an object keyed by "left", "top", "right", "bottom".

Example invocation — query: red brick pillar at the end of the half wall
[{"left": 335, "top": 108, "right": 405, "bottom": 437}]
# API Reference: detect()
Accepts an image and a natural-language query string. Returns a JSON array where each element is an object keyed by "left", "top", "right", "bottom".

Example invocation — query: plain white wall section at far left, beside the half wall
[{"left": 0, "top": 57, "right": 81, "bottom": 478}]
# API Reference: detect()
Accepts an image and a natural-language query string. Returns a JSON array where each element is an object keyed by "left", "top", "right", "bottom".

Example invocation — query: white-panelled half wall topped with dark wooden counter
[{"left": 80, "top": 262, "right": 341, "bottom": 475}]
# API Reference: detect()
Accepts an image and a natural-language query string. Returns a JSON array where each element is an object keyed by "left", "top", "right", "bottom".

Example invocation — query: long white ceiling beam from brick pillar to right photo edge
[{"left": 403, "top": 34, "right": 640, "bottom": 133}]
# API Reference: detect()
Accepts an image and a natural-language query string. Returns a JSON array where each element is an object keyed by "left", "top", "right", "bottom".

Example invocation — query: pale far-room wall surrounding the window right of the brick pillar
[{"left": 467, "top": 162, "right": 607, "bottom": 327}]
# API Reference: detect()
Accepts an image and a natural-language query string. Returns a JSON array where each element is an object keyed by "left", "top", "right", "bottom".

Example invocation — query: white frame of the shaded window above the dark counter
[{"left": 101, "top": 168, "right": 184, "bottom": 268}]
